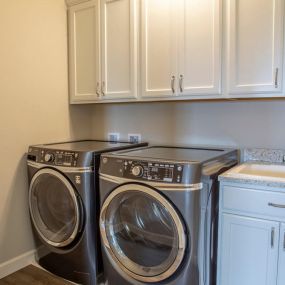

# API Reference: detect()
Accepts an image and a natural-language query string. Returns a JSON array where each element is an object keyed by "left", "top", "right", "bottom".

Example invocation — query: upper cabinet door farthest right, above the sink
[{"left": 227, "top": 0, "right": 284, "bottom": 94}]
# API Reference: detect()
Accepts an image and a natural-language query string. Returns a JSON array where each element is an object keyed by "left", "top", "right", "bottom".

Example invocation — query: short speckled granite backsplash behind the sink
[{"left": 241, "top": 148, "right": 285, "bottom": 163}]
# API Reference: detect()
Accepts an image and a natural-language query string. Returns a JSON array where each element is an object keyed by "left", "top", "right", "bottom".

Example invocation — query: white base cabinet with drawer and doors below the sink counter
[{"left": 217, "top": 183, "right": 285, "bottom": 285}]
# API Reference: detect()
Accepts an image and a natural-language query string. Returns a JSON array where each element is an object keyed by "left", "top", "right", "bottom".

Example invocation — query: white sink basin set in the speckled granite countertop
[{"left": 229, "top": 163, "right": 285, "bottom": 179}]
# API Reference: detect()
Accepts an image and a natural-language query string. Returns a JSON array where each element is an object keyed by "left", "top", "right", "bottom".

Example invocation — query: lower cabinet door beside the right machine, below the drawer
[{"left": 218, "top": 214, "right": 279, "bottom": 285}]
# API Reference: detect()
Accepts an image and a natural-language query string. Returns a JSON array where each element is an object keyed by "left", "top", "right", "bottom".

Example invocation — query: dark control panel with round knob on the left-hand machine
[{"left": 28, "top": 146, "right": 79, "bottom": 167}]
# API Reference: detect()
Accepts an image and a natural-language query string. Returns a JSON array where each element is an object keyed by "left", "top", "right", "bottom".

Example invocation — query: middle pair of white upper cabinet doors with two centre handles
[{"left": 141, "top": 0, "right": 221, "bottom": 97}]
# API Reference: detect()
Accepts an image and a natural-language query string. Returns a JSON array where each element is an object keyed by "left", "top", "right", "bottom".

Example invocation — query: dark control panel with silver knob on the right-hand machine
[{"left": 123, "top": 160, "right": 183, "bottom": 183}]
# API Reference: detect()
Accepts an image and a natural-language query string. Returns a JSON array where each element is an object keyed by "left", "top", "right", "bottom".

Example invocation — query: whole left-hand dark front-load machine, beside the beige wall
[{"left": 27, "top": 140, "right": 146, "bottom": 285}]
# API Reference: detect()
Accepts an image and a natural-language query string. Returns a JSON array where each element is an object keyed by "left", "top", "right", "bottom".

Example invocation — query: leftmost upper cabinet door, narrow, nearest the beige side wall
[{"left": 68, "top": 1, "right": 100, "bottom": 103}]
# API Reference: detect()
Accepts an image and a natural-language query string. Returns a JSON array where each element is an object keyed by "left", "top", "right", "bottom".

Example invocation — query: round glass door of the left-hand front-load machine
[{"left": 29, "top": 168, "right": 83, "bottom": 248}]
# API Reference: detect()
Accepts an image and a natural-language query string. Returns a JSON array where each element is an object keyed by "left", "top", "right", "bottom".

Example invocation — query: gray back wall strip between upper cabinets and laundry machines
[{"left": 93, "top": 100, "right": 285, "bottom": 149}]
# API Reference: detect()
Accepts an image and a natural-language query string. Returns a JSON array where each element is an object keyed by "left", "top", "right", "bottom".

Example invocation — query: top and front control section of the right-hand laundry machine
[{"left": 100, "top": 146, "right": 237, "bottom": 185}]
